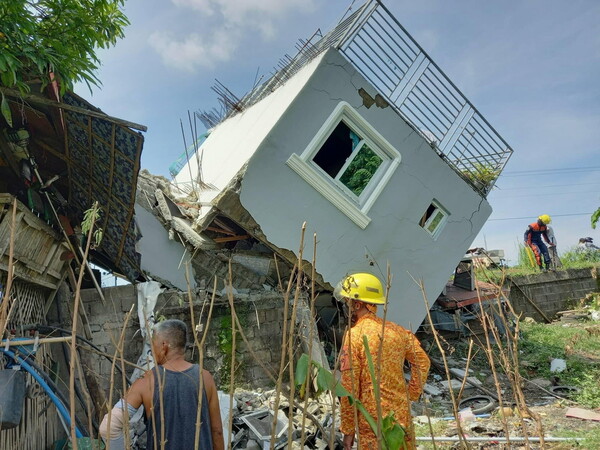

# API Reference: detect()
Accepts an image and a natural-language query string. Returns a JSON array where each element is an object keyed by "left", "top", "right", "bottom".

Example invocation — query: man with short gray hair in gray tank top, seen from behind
[{"left": 100, "top": 319, "right": 224, "bottom": 450}]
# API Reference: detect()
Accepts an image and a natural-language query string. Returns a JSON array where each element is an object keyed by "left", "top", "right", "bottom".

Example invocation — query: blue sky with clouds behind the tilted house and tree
[{"left": 76, "top": 0, "right": 600, "bottom": 262}]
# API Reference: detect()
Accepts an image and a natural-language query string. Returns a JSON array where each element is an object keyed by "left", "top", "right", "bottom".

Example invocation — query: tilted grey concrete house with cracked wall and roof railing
[{"left": 175, "top": 1, "right": 512, "bottom": 329}]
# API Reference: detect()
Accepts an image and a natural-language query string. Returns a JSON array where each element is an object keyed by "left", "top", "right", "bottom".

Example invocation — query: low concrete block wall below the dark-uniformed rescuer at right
[{"left": 509, "top": 267, "right": 600, "bottom": 321}]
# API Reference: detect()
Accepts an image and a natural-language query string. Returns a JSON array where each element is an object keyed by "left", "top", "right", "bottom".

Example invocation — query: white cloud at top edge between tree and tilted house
[{"left": 148, "top": 0, "right": 315, "bottom": 72}]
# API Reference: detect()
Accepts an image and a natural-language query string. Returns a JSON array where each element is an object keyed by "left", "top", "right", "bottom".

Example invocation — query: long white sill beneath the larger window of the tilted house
[{"left": 286, "top": 153, "right": 371, "bottom": 230}]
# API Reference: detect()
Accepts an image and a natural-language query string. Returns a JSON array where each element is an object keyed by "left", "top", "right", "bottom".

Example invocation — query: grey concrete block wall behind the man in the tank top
[{"left": 82, "top": 285, "right": 291, "bottom": 392}]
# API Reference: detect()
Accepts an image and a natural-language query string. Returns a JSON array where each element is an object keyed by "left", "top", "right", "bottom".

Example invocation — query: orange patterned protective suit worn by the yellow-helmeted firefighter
[{"left": 340, "top": 313, "right": 430, "bottom": 450}]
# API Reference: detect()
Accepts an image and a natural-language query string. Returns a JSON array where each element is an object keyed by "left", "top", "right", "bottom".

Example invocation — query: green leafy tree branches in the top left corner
[{"left": 0, "top": 0, "right": 129, "bottom": 94}]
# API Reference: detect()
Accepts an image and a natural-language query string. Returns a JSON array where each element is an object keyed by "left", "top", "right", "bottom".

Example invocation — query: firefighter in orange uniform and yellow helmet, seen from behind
[{"left": 335, "top": 273, "right": 430, "bottom": 450}]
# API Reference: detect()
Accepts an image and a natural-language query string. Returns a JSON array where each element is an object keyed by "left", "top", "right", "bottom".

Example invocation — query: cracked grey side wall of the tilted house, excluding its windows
[{"left": 240, "top": 49, "right": 491, "bottom": 329}]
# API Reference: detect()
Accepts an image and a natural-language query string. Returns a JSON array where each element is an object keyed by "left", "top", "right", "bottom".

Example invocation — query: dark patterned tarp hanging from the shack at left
[{"left": 63, "top": 94, "right": 144, "bottom": 280}]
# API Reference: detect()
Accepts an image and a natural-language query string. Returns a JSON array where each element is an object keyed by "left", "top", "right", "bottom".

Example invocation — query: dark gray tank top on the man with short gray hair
[{"left": 146, "top": 364, "right": 213, "bottom": 450}]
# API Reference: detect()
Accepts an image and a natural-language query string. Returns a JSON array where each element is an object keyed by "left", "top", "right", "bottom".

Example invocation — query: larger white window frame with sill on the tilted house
[{"left": 286, "top": 102, "right": 400, "bottom": 229}]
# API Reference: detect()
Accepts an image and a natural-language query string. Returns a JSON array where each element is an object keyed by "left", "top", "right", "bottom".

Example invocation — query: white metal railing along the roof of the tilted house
[{"left": 336, "top": 0, "right": 513, "bottom": 196}]
